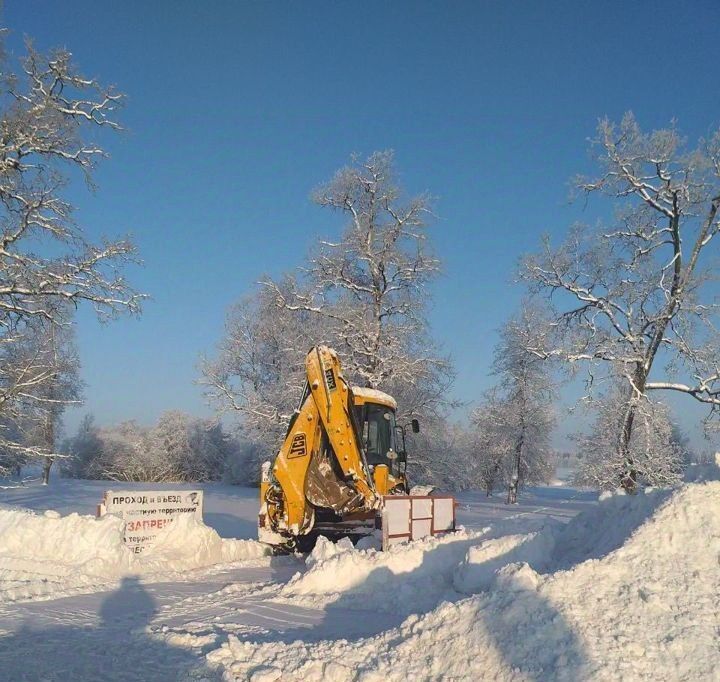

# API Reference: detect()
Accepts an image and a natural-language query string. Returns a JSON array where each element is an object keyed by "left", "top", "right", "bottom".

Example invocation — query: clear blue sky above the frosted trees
[{"left": 4, "top": 0, "right": 720, "bottom": 444}]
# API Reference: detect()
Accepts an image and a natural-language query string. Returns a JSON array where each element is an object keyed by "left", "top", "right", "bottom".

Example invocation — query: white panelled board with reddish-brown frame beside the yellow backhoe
[{"left": 377, "top": 495, "right": 456, "bottom": 550}]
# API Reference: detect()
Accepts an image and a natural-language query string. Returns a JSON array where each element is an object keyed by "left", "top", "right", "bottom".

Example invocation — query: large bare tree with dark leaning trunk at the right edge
[{"left": 521, "top": 114, "right": 720, "bottom": 491}]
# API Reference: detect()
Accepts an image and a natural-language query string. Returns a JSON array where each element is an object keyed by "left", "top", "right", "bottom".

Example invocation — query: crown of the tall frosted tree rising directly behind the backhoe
[{"left": 265, "top": 152, "right": 448, "bottom": 398}]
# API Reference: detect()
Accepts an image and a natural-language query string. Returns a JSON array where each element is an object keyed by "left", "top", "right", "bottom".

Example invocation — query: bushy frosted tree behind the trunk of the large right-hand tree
[{"left": 575, "top": 385, "right": 683, "bottom": 490}]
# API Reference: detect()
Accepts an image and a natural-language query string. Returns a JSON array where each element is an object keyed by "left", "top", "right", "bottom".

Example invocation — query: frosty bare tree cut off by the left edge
[{"left": 0, "top": 34, "right": 143, "bottom": 464}]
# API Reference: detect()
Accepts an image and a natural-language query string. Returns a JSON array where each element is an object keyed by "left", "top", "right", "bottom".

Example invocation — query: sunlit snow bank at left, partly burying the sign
[{"left": 0, "top": 502, "right": 267, "bottom": 601}]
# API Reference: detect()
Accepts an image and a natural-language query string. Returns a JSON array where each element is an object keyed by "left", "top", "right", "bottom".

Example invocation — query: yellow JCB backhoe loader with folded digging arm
[{"left": 258, "top": 346, "right": 455, "bottom": 551}]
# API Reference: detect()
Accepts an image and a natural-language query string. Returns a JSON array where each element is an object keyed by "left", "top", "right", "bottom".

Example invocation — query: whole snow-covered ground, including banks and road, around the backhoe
[{"left": 0, "top": 469, "right": 720, "bottom": 682}]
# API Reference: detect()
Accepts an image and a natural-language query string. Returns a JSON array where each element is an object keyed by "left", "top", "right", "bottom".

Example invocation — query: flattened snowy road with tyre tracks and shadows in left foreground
[{"left": 0, "top": 558, "right": 376, "bottom": 682}]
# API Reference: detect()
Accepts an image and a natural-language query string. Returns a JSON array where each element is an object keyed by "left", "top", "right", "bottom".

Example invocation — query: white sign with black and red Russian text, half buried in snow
[{"left": 98, "top": 490, "right": 202, "bottom": 554}]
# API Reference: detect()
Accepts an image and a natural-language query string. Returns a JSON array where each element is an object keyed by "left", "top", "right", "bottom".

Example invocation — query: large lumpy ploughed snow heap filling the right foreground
[{"left": 208, "top": 482, "right": 720, "bottom": 682}]
